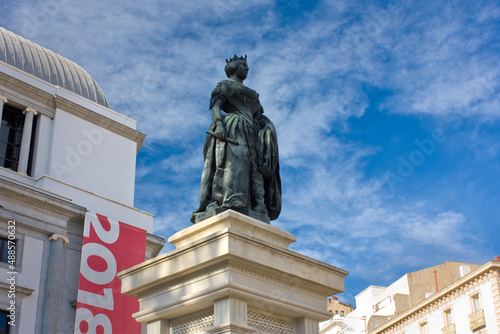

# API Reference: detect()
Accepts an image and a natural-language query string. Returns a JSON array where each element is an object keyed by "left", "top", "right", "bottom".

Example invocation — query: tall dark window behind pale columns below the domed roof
[{"left": 0, "top": 104, "right": 37, "bottom": 175}]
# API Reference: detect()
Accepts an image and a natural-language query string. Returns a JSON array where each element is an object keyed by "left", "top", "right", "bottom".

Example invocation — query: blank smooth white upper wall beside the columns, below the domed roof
[{"left": 48, "top": 109, "right": 137, "bottom": 206}]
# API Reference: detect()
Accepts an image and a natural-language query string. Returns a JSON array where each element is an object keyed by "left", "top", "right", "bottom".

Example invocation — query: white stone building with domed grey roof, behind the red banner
[{"left": 0, "top": 28, "right": 165, "bottom": 334}]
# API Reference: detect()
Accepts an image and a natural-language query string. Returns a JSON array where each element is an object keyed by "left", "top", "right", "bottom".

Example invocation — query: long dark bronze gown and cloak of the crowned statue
[{"left": 191, "top": 80, "right": 281, "bottom": 223}]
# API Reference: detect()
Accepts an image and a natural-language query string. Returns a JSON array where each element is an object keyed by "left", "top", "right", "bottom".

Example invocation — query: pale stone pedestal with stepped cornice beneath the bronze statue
[{"left": 119, "top": 210, "right": 347, "bottom": 334}]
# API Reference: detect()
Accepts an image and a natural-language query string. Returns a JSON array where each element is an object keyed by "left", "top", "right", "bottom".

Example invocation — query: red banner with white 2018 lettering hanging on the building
[{"left": 75, "top": 213, "right": 146, "bottom": 334}]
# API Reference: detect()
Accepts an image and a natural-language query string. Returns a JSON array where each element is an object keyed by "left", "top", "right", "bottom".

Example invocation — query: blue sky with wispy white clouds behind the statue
[{"left": 0, "top": 0, "right": 500, "bottom": 303}]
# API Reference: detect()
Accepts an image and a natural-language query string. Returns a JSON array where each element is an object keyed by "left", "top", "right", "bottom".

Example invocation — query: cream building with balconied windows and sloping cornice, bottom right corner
[{"left": 369, "top": 258, "right": 500, "bottom": 334}]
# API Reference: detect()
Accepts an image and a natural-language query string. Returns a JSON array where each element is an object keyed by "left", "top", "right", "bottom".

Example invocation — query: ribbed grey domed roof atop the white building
[{"left": 0, "top": 27, "right": 109, "bottom": 108}]
